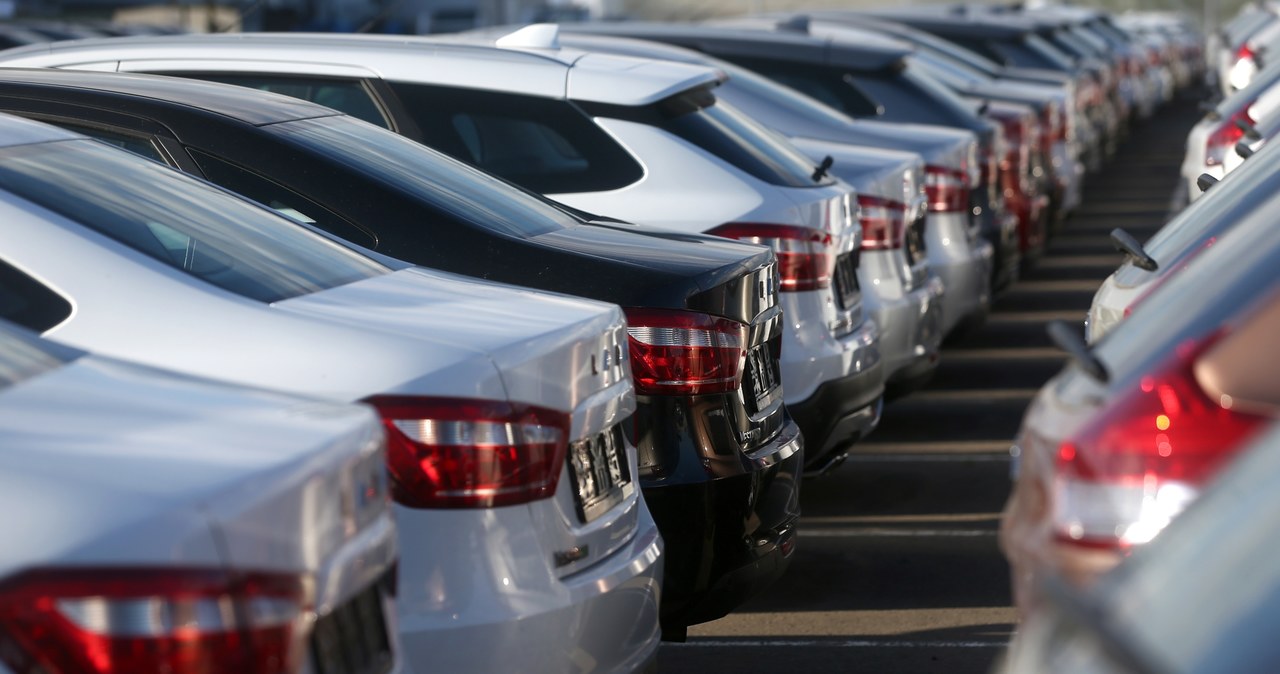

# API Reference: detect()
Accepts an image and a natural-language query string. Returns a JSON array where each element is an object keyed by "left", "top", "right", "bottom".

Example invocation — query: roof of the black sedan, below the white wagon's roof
[{"left": 0, "top": 68, "right": 342, "bottom": 127}]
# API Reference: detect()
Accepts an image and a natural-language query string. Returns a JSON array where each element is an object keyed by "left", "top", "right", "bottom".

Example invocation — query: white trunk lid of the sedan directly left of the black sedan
[{"left": 276, "top": 267, "right": 635, "bottom": 436}]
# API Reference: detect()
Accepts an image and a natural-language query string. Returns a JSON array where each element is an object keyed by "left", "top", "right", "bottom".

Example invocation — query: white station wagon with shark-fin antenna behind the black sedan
[{"left": 4, "top": 26, "right": 884, "bottom": 473}]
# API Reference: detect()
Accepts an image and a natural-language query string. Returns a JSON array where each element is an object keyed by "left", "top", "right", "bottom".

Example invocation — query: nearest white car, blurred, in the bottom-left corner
[{"left": 0, "top": 321, "right": 406, "bottom": 674}]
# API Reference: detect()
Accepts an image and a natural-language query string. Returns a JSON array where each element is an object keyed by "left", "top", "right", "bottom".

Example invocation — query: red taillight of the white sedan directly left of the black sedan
[{"left": 365, "top": 395, "right": 570, "bottom": 508}]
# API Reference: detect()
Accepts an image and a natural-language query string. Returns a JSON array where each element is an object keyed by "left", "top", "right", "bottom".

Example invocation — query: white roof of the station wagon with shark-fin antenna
[{"left": 0, "top": 27, "right": 719, "bottom": 105}]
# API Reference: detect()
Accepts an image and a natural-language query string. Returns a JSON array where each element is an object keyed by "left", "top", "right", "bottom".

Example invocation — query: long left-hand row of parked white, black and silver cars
[{"left": 0, "top": 8, "right": 1198, "bottom": 673}]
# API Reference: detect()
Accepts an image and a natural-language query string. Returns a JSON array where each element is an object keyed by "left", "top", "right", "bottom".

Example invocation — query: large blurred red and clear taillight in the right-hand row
[{"left": 1053, "top": 333, "right": 1267, "bottom": 549}]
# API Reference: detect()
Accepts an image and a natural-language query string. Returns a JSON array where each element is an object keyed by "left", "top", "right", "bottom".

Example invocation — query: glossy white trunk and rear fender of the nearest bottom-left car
[{"left": 0, "top": 356, "right": 394, "bottom": 576}]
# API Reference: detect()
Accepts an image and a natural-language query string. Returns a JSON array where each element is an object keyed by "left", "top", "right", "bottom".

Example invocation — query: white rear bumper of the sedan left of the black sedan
[{"left": 397, "top": 503, "right": 664, "bottom": 673}]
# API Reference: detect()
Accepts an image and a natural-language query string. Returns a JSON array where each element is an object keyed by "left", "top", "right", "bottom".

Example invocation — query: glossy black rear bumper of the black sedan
[{"left": 641, "top": 419, "right": 804, "bottom": 631}]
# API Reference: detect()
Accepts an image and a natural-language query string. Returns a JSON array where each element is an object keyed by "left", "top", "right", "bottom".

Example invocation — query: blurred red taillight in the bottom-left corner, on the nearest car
[{"left": 0, "top": 568, "right": 311, "bottom": 674}]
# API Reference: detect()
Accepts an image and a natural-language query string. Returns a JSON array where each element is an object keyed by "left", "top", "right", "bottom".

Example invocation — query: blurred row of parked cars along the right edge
[{"left": 1000, "top": 6, "right": 1280, "bottom": 673}]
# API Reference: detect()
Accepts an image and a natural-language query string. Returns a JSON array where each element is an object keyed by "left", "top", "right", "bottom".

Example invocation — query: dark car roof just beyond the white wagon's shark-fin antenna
[{"left": 564, "top": 22, "right": 914, "bottom": 70}]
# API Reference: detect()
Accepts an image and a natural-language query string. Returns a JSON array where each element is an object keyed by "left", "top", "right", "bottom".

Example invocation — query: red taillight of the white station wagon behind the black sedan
[{"left": 708, "top": 223, "right": 836, "bottom": 293}]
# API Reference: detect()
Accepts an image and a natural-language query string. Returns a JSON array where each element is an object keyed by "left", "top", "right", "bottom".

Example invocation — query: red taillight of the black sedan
[{"left": 625, "top": 308, "right": 748, "bottom": 395}]
